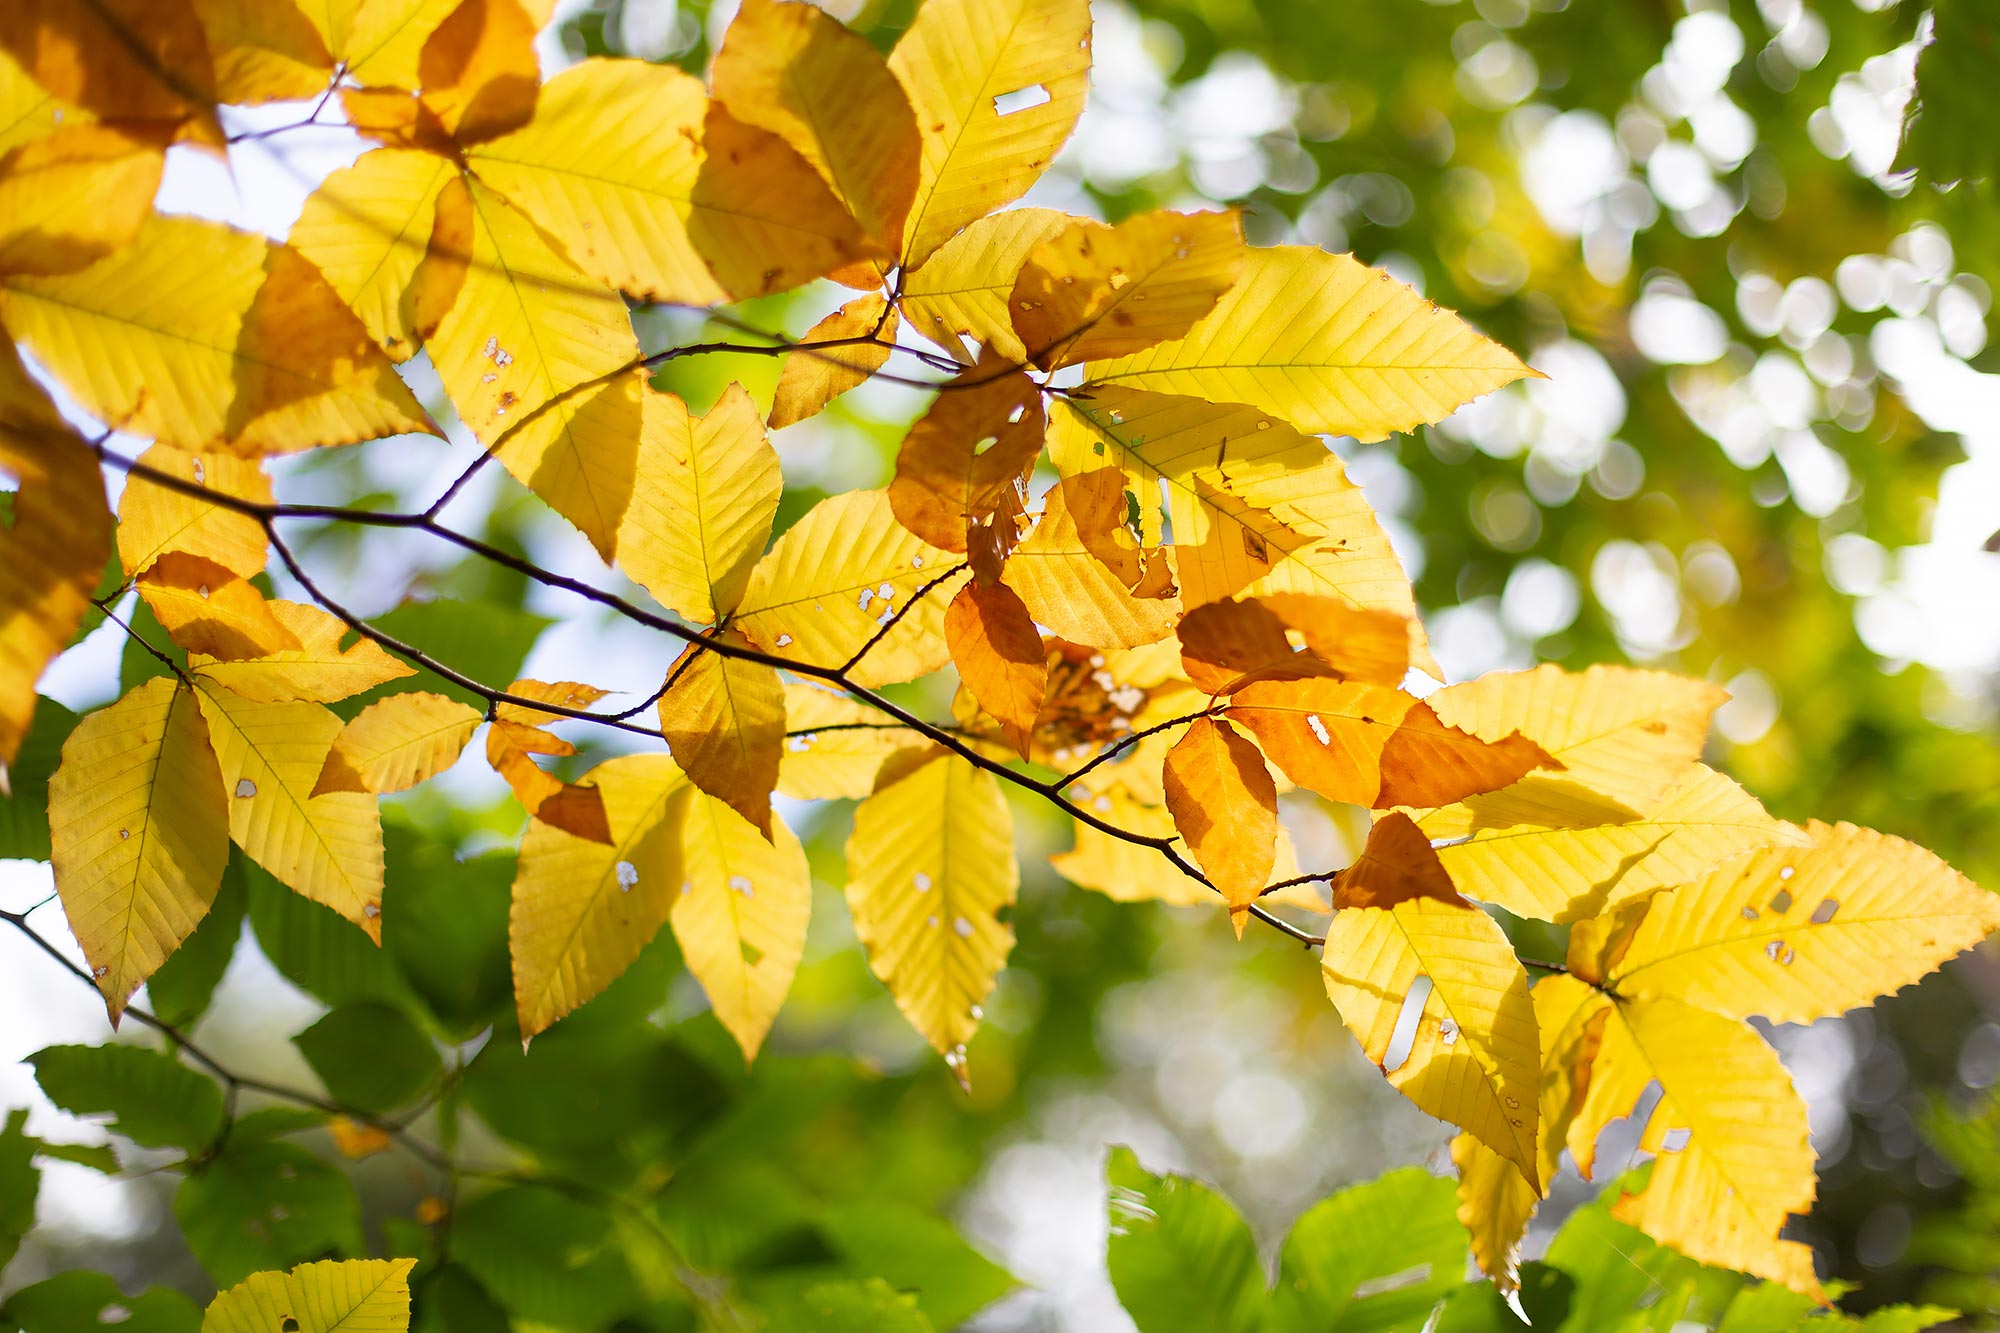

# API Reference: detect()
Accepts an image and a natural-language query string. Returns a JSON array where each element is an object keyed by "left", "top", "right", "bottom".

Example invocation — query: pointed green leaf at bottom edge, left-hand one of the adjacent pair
[{"left": 1104, "top": 1147, "right": 1264, "bottom": 1333}]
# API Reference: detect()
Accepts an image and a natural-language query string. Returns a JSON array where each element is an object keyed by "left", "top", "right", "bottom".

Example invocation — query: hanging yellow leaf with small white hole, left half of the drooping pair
[{"left": 508, "top": 755, "right": 692, "bottom": 1039}]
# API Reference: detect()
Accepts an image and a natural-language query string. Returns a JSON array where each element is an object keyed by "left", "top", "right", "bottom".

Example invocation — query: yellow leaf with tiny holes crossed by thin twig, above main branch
[{"left": 734, "top": 490, "right": 962, "bottom": 687}]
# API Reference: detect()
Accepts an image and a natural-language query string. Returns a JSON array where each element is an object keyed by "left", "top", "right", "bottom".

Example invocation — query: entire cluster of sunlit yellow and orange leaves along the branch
[{"left": 0, "top": 0, "right": 2000, "bottom": 1288}]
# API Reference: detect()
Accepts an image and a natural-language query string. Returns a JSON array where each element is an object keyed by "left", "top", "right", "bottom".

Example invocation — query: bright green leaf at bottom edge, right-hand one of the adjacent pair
[{"left": 1264, "top": 1167, "right": 1466, "bottom": 1333}]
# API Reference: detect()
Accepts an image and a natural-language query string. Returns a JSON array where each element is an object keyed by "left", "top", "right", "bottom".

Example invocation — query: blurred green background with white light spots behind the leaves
[{"left": 0, "top": 0, "right": 2000, "bottom": 1331}]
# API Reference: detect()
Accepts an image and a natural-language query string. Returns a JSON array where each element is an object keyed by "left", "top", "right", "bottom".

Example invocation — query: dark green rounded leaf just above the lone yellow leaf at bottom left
[{"left": 174, "top": 1139, "right": 366, "bottom": 1287}]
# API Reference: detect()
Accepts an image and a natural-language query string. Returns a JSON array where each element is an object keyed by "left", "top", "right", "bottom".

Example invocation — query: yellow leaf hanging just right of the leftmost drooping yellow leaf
[{"left": 194, "top": 667, "right": 382, "bottom": 932}]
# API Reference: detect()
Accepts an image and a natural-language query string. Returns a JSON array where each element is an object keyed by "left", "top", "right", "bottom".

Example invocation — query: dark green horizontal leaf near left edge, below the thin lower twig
[{"left": 28, "top": 1045, "right": 222, "bottom": 1153}]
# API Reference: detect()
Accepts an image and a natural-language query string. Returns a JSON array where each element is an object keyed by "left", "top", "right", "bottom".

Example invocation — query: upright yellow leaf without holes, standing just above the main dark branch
[{"left": 618, "top": 384, "right": 784, "bottom": 624}]
